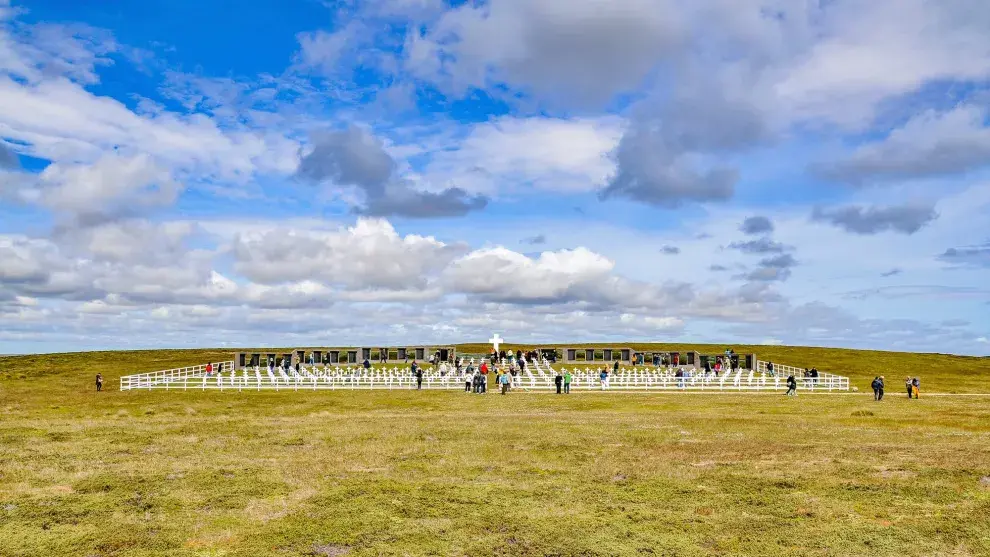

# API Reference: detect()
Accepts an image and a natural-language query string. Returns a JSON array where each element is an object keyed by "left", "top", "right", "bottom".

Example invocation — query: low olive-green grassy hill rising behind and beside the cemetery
[{"left": 0, "top": 343, "right": 990, "bottom": 393}]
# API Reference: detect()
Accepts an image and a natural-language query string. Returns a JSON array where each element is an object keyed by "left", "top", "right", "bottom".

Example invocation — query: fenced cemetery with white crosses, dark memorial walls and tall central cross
[{"left": 120, "top": 335, "right": 850, "bottom": 393}]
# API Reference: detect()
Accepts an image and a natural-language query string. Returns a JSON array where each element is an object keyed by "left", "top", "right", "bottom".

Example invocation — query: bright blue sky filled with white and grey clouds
[{"left": 0, "top": 0, "right": 990, "bottom": 355}]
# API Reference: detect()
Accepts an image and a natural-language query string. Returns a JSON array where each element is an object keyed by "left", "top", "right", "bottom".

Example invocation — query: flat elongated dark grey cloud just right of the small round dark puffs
[{"left": 811, "top": 204, "right": 938, "bottom": 234}]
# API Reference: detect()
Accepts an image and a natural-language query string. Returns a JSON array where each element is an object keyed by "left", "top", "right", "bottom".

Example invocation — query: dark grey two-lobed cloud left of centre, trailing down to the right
[{"left": 297, "top": 127, "right": 488, "bottom": 218}]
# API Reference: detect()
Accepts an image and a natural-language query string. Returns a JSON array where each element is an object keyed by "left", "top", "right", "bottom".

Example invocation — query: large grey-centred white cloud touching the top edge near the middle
[{"left": 406, "top": 0, "right": 683, "bottom": 105}]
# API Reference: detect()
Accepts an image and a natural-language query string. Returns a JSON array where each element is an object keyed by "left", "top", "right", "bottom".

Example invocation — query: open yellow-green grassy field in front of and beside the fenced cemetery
[{"left": 0, "top": 347, "right": 990, "bottom": 557}]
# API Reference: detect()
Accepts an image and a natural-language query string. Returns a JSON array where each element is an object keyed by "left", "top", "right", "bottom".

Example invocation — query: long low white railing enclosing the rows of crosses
[{"left": 121, "top": 362, "right": 849, "bottom": 393}]
